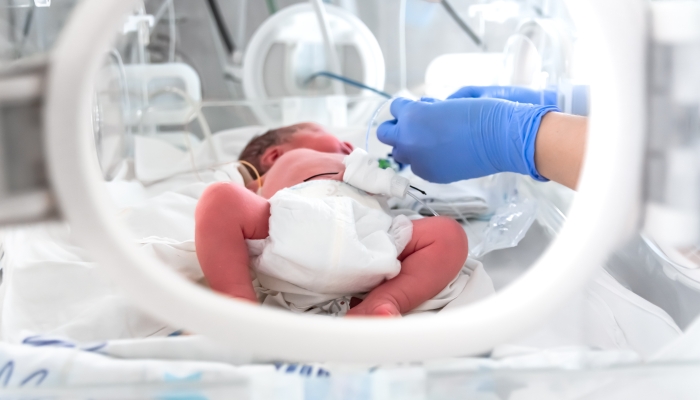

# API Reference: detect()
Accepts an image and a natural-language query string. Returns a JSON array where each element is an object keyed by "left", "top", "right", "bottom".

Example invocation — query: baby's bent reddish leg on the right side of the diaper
[{"left": 348, "top": 217, "right": 469, "bottom": 316}]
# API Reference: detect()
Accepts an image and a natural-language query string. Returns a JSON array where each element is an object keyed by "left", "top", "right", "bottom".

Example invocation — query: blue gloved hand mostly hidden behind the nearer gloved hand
[{"left": 448, "top": 86, "right": 557, "bottom": 106}]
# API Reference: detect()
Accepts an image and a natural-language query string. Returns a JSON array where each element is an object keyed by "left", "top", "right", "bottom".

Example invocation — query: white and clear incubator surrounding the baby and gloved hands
[{"left": 0, "top": 0, "right": 700, "bottom": 399}]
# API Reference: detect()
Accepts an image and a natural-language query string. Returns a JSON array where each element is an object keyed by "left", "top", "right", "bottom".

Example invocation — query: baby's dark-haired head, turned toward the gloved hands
[{"left": 238, "top": 122, "right": 353, "bottom": 175}]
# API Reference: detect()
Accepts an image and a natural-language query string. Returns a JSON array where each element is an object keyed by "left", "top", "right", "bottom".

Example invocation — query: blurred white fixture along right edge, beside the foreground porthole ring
[{"left": 644, "top": 2, "right": 700, "bottom": 278}]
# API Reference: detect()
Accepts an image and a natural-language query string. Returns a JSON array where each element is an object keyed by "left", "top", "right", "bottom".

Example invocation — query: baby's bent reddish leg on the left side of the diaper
[{"left": 195, "top": 183, "right": 270, "bottom": 302}]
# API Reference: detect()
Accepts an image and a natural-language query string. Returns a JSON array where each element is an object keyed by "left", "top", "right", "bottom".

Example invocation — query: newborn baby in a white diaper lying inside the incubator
[{"left": 195, "top": 124, "right": 468, "bottom": 316}]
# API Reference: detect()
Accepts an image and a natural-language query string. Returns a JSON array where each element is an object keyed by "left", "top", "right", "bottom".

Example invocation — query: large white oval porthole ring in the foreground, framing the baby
[{"left": 3, "top": 0, "right": 649, "bottom": 362}]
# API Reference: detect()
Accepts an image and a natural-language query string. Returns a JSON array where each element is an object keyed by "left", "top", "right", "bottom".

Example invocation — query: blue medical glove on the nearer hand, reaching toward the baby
[{"left": 377, "top": 98, "right": 558, "bottom": 183}]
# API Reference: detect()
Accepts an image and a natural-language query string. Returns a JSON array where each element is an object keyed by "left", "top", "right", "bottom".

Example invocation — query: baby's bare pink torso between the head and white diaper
[{"left": 260, "top": 149, "right": 345, "bottom": 199}]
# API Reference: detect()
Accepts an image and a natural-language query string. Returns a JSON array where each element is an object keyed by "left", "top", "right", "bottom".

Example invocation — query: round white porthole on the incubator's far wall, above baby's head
[{"left": 241, "top": 1, "right": 385, "bottom": 126}]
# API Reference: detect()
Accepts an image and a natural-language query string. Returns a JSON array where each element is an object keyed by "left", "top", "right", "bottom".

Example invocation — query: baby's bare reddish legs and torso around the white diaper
[{"left": 195, "top": 134, "right": 468, "bottom": 316}]
